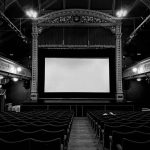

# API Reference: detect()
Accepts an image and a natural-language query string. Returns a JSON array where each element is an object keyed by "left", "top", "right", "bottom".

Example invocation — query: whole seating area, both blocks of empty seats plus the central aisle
[{"left": 0, "top": 110, "right": 150, "bottom": 150}]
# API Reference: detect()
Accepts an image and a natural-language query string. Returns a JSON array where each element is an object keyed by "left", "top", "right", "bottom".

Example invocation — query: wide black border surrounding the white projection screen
[{"left": 38, "top": 48, "right": 116, "bottom": 98}]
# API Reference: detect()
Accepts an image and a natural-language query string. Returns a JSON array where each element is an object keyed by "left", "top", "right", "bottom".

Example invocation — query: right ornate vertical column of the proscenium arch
[{"left": 116, "top": 20, "right": 124, "bottom": 102}]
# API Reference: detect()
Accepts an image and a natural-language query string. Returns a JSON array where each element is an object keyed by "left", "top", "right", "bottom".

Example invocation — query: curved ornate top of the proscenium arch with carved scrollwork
[{"left": 37, "top": 9, "right": 118, "bottom": 26}]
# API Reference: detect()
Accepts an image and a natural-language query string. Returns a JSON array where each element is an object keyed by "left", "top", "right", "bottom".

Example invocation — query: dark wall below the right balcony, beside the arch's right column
[{"left": 124, "top": 79, "right": 150, "bottom": 104}]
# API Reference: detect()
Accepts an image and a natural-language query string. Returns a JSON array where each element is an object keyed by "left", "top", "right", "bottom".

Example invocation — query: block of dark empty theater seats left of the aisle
[{"left": 0, "top": 110, "right": 74, "bottom": 150}]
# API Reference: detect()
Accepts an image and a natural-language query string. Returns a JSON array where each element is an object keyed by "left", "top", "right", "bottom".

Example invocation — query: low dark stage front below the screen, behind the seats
[{"left": 21, "top": 100, "right": 137, "bottom": 117}]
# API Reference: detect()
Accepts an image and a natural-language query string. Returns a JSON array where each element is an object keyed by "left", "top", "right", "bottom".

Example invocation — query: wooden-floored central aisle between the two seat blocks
[{"left": 68, "top": 117, "right": 101, "bottom": 150}]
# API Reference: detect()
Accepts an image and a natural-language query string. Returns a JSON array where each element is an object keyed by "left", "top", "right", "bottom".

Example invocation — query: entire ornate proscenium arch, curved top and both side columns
[{"left": 31, "top": 9, "right": 123, "bottom": 102}]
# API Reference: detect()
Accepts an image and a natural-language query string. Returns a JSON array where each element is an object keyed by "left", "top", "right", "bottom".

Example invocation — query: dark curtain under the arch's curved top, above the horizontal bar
[{"left": 39, "top": 27, "right": 115, "bottom": 45}]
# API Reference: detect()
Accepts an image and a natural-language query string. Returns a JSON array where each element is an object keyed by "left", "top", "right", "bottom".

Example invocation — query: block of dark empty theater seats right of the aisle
[{"left": 87, "top": 110, "right": 150, "bottom": 150}]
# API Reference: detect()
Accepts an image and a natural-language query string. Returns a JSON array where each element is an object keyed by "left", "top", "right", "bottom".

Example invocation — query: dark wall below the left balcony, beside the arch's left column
[{"left": 5, "top": 80, "right": 30, "bottom": 105}]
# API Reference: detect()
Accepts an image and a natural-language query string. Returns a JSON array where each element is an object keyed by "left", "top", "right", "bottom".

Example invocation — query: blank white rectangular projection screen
[{"left": 44, "top": 58, "right": 110, "bottom": 93}]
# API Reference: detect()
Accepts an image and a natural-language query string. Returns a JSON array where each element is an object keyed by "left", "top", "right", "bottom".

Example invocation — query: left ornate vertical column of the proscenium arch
[{"left": 31, "top": 20, "right": 38, "bottom": 102}]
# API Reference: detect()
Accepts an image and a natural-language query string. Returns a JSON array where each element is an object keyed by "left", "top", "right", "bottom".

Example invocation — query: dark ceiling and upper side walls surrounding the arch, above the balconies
[{"left": 0, "top": 0, "right": 150, "bottom": 67}]
